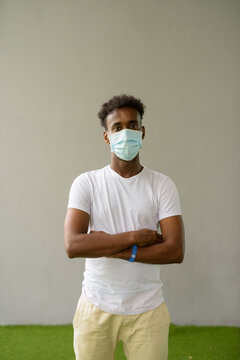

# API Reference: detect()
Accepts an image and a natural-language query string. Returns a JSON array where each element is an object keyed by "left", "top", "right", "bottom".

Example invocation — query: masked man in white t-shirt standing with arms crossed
[{"left": 64, "top": 94, "right": 185, "bottom": 360}]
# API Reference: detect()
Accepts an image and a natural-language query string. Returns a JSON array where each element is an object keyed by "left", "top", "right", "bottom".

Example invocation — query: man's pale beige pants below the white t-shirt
[{"left": 72, "top": 294, "right": 170, "bottom": 360}]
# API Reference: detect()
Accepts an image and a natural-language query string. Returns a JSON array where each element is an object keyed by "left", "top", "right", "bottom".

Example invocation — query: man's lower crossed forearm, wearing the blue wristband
[{"left": 110, "top": 242, "right": 182, "bottom": 265}]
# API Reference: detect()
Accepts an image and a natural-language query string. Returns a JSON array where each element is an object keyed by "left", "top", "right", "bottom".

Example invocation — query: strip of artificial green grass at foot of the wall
[{"left": 0, "top": 324, "right": 240, "bottom": 360}]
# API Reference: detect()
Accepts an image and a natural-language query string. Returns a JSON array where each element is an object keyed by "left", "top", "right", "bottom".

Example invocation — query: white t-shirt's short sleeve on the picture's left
[{"left": 67, "top": 173, "right": 91, "bottom": 214}]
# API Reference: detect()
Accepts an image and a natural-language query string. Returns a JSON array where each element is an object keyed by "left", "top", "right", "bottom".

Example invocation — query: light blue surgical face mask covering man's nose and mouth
[{"left": 108, "top": 129, "right": 142, "bottom": 161}]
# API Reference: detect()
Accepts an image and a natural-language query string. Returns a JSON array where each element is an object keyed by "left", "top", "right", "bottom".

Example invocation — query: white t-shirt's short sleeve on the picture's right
[{"left": 158, "top": 176, "right": 182, "bottom": 221}]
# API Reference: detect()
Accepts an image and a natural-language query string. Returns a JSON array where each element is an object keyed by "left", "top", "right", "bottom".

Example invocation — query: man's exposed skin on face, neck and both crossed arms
[{"left": 64, "top": 107, "right": 185, "bottom": 264}]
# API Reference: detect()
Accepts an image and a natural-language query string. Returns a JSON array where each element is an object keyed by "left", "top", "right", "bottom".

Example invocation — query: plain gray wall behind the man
[{"left": 0, "top": 0, "right": 240, "bottom": 325}]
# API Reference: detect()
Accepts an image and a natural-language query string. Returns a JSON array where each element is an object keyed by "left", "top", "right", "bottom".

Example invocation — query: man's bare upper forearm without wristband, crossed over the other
[{"left": 68, "top": 231, "right": 133, "bottom": 258}]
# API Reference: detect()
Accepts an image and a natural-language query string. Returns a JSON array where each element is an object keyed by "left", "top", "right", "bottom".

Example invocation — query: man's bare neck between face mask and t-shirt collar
[{"left": 110, "top": 152, "right": 143, "bottom": 178}]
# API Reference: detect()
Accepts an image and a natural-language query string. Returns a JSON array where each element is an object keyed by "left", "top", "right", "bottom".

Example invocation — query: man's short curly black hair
[{"left": 98, "top": 94, "right": 146, "bottom": 130}]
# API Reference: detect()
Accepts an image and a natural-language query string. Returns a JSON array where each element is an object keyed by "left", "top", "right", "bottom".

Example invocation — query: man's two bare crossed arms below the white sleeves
[{"left": 64, "top": 208, "right": 185, "bottom": 264}]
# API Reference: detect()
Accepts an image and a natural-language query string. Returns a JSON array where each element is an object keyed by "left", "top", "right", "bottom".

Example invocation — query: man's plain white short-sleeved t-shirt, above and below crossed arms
[{"left": 68, "top": 165, "right": 182, "bottom": 315}]
